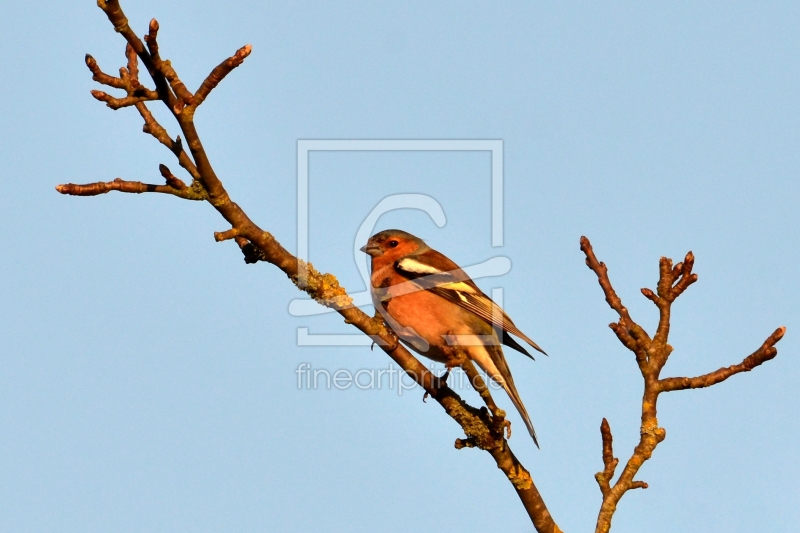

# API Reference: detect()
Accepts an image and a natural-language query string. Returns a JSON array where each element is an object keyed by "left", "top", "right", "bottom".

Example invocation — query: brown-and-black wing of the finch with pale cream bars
[{"left": 394, "top": 249, "right": 546, "bottom": 359}]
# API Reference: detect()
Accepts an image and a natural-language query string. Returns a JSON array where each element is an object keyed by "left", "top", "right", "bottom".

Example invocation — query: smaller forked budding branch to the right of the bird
[{"left": 580, "top": 237, "right": 786, "bottom": 533}]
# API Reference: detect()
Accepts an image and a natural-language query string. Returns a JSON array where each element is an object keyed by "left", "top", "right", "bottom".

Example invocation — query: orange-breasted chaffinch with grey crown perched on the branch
[{"left": 361, "top": 229, "right": 546, "bottom": 447}]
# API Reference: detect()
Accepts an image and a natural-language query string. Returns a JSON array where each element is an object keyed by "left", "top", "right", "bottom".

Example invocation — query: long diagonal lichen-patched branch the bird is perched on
[{"left": 56, "top": 0, "right": 561, "bottom": 533}]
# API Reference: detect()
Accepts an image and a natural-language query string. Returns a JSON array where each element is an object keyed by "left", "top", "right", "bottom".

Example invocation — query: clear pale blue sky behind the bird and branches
[{"left": 0, "top": 1, "right": 800, "bottom": 533}]
